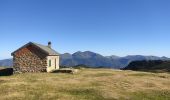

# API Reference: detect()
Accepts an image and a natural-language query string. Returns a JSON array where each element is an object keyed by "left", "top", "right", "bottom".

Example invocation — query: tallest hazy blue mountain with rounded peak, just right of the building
[{"left": 60, "top": 51, "right": 113, "bottom": 67}]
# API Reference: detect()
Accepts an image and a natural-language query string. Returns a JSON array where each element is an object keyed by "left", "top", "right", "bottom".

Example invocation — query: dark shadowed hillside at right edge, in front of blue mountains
[{"left": 124, "top": 60, "right": 170, "bottom": 72}]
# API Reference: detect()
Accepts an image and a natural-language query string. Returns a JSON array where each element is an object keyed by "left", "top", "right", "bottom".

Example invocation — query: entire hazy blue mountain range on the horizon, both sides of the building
[{"left": 0, "top": 51, "right": 170, "bottom": 69}]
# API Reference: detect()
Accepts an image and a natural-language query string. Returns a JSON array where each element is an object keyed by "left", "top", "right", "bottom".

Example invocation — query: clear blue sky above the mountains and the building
[{"left": 0, "top": 0, "right": 170, "bottom": 59}]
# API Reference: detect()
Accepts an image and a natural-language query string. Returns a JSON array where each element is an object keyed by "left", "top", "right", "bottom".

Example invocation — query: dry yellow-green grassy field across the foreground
[{"left": 0, "top": 69, "right": 170, "bottom": 100}]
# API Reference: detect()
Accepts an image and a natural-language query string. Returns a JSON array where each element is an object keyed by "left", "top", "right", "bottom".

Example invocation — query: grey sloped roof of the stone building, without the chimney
[{"left": 12, "top": 42, "right": 60, "bottom": 56}]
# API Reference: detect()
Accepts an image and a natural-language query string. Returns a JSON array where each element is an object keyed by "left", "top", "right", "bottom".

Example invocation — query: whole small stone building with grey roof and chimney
[{"left": 11, "top": 42, "right": 59, "bottom": 73}]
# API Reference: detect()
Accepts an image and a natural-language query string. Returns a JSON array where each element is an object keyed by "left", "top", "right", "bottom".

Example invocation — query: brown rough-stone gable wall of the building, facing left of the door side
[{"left": 13, "top": 45, "right": 47, "bottom": 72}]
